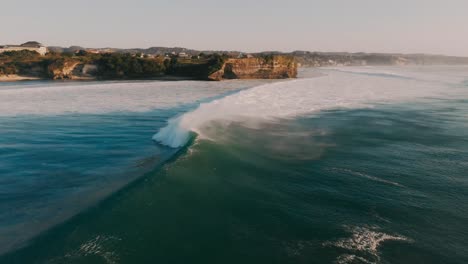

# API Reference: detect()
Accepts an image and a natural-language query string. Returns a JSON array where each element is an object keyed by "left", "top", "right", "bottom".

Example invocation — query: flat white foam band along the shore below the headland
[{"left": 0, "top": 81, "right": 261, "bottom": 117}]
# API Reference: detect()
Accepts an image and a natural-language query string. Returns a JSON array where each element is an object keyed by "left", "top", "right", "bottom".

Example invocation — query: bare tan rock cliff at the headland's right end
[{"left": 208, "top": 56, "right": 297, "bottom": 81}]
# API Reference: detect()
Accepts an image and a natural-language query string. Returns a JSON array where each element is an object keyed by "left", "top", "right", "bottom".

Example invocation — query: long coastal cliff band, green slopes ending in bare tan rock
[{"left": 0, "top": 55, "right": 297, "bottom": 81}]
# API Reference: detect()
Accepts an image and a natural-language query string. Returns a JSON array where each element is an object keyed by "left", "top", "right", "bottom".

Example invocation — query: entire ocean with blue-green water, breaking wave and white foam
[{"left": 0, "top": 66, "right": 468, "bottom": 264}]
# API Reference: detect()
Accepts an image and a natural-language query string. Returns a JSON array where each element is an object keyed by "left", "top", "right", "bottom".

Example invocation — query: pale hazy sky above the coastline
[{"left": 0, "top": 0, "right": 468, "bottom": 56}]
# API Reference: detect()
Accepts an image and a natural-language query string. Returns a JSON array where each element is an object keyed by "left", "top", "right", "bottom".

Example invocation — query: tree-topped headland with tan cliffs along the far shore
[{"left": 0, "top": 50, "right": 296, "bottom": 80}]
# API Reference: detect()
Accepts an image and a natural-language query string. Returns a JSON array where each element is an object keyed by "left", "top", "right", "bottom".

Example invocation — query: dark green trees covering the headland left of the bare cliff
[{"left": 0, "top": 50, "right": 227, "bottom": 79}]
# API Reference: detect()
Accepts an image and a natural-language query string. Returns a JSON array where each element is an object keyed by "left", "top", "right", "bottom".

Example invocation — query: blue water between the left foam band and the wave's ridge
[{"left": 0, "top": 110, "right": 177, "bottom": 254}]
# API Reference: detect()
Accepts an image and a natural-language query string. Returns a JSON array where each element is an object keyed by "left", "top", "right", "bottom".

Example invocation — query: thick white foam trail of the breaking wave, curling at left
[{"left": 153, "top": 68, "right": 458, "bottom": 147}]
